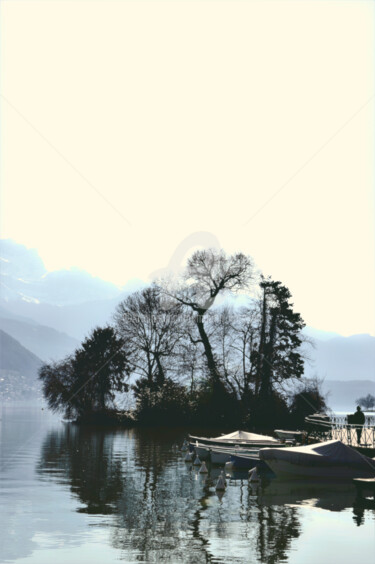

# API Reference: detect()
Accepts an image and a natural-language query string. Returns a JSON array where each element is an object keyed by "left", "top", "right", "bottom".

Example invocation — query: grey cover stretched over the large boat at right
[{"left": 259, "top": 440, "right": 375, "bottom": 473}]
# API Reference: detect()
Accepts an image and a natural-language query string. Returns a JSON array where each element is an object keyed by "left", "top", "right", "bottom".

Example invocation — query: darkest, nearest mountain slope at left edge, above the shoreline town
[{"left": 0, "top": 330, "right": 42, "bottom": 399}]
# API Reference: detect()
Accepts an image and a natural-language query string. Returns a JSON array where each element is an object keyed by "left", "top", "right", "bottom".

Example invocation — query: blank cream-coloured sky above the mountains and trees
[{"left": 1, "top": 0, "right": 375, "bottom": 334}]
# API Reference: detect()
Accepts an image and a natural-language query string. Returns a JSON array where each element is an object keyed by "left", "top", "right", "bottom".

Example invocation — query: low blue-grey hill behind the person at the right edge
[{"left": 323, "top": 380, "right": 375, "bottom": 413}]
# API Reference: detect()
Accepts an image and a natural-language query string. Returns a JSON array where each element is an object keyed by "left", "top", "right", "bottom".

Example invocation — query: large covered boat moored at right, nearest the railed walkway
[{"left": 259, "top": 440, "right": 375, "bottom": 480}]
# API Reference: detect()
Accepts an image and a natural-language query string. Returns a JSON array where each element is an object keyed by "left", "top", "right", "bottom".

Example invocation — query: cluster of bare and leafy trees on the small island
[{"left": 40, "top": 249, "right": 321, "bottom": 427}]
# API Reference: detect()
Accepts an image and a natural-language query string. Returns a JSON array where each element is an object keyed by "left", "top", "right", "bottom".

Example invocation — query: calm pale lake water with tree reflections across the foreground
[{"left": 0, "top": 404, "right": 375, "bottom": 564}]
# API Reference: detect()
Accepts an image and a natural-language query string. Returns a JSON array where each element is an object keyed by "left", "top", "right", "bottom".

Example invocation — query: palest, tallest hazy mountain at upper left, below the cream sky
[{"left": 0, "top": 239, "right": 144, "bottom": 340}]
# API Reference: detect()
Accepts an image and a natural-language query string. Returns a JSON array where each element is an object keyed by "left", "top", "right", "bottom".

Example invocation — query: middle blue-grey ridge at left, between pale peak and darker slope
[{"left": 0, "top": 316, "right": 80, "bottom": 361}]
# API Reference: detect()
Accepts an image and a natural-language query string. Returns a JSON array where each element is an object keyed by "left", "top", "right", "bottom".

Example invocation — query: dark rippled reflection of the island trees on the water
[{"left": 38, "top": 425, "right": 374, "bottom": 564}]
